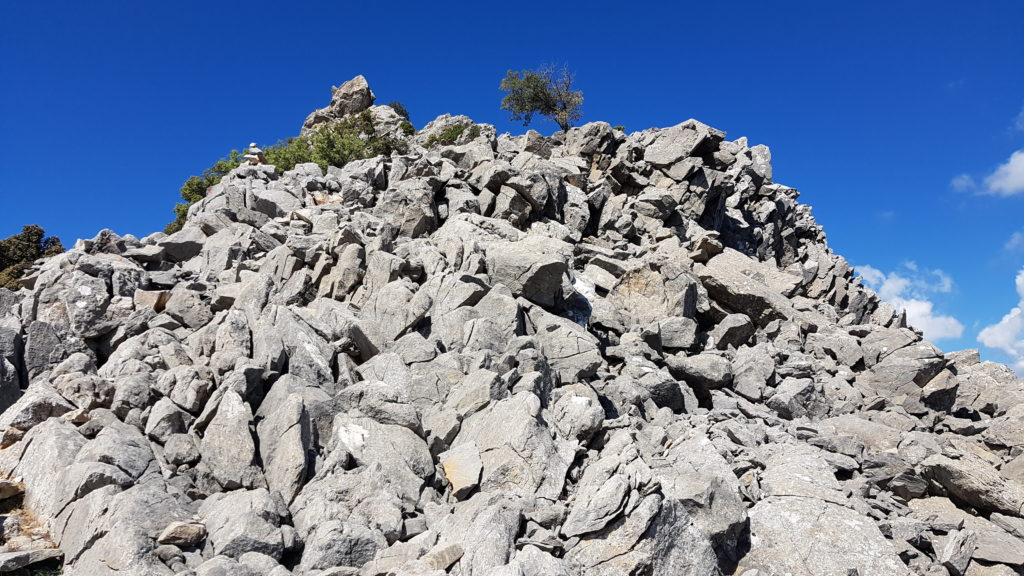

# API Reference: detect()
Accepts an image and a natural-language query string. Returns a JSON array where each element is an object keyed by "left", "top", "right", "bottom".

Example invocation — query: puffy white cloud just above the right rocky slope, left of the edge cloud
[{"left": 856, "top": 262, "right": 964, "bottom": 340}]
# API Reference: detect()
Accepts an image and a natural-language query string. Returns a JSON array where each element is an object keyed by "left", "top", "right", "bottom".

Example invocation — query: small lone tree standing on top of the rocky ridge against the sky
[{"left": 501, "top": 66, "right": 583, "bottom": 131}]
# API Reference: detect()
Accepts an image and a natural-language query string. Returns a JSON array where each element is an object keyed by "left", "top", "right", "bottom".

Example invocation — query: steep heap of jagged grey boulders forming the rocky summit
[{"left": 0, "top": 77, "right": 1024, "bottom": 576}]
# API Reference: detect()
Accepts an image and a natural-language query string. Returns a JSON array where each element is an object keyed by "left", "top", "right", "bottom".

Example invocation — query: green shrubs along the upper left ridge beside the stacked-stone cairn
[{"left": 164, "top": 110, "right": 405, "bottom": 234}]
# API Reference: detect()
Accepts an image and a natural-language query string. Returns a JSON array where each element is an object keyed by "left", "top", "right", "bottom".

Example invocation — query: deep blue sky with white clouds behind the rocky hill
[{"left": 0, "top": 0, "right": 1024, "bottom": 368}]
